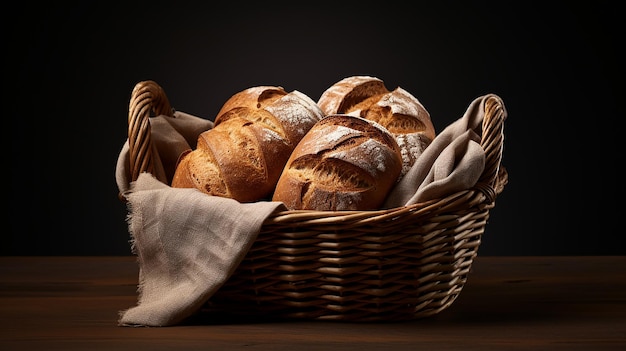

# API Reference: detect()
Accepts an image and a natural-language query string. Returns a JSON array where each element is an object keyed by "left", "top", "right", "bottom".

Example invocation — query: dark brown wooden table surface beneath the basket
[{"left": 0, "top": 256, "right": 626, "bottom": 351}]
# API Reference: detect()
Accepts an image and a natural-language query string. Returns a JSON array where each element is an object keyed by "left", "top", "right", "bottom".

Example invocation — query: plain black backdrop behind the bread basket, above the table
[{"left": 7, "top": 1, "right": 626, "bottom": 255}]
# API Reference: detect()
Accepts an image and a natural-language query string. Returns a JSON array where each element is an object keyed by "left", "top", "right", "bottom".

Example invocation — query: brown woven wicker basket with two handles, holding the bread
[{"left": 123, "top": 81, "right": 508, "bottom": 322}]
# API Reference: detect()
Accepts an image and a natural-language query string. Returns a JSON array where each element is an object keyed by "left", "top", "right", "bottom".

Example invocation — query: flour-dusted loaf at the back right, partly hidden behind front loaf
[{"left": 317, "top": 76, "right": 435, "bottom": 178}]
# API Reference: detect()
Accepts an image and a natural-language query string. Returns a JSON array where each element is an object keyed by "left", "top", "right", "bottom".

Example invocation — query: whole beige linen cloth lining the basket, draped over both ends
[{"left": 115, "top": 94, "right": 502, "bottom": 327}]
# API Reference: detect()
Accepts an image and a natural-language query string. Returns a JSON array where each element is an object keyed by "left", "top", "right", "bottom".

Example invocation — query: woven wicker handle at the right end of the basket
[{"left": 478, "top": 94, "right": 508, "bottom": 202}]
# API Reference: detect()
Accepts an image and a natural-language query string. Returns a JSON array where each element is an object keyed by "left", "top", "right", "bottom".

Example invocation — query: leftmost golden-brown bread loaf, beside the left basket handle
[{"left": 171, "top": 86, "right": 323, "bottom": 202}]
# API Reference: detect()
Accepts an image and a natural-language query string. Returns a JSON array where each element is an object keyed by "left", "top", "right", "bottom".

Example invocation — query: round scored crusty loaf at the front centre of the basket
[{"left": 272, "top": 114, "right": 402, "bottom": 211}]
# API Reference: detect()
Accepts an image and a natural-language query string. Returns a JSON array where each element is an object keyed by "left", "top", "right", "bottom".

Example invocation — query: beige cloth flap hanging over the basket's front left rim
[{"left": 118, "top": 173, "right": 284, "bottom": 326}]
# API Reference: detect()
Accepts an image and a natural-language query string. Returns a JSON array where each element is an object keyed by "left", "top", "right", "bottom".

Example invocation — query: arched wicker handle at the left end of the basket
[{"left": 128, "top": 80, "right": 174, "bottom": 181}]
